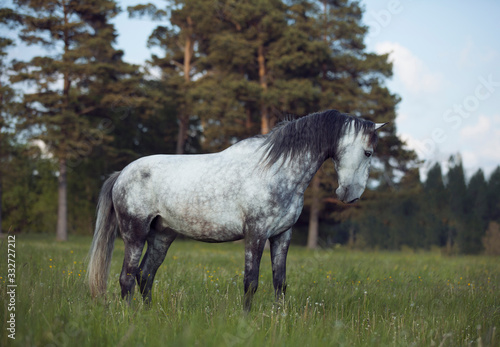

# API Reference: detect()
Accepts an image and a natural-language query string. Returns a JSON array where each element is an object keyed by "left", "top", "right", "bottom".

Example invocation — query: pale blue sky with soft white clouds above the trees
[{"left": 4, "top": 0, "right": 500, "bottom": 178}]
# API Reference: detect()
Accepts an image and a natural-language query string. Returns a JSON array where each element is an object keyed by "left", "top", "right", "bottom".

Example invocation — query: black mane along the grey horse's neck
[{"left": 261, "top": 110, "right": 377, "bottom": 167}]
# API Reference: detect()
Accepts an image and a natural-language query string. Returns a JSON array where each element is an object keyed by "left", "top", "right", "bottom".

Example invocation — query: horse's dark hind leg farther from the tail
[{"left": 136, "top": 229, "right": 177, "bottom": 304}]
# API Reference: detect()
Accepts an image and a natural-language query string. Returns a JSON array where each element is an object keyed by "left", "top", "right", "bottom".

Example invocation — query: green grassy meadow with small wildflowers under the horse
[{"left": 0, "top": 235, "right": 500, "bottom": 347}]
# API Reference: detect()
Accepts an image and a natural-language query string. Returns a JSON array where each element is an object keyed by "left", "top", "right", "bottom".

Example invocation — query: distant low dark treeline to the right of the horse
[{"left": 325, "top": 160, "right": 500, "bottom": 254}]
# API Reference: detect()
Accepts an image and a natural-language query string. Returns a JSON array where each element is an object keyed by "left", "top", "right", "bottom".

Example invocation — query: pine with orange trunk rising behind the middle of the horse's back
[{"left": 189, "top": 0, "right": 287, "bottom": 151}]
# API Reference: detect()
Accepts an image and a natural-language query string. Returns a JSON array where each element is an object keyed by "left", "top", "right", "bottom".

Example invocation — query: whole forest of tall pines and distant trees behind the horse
[{"left": 0, "top": 0, "right": 500, "bottom": 253}]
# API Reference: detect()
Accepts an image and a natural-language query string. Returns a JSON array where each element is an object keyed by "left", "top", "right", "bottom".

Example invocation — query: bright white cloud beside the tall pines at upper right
[{"left": 375, "top": 41, "right": 443, "bottom": 93}]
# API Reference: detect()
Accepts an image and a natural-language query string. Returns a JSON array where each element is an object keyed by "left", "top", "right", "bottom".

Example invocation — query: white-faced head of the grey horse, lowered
[{"left": 333, "top": 123, "right": 387, "bottom": 204}]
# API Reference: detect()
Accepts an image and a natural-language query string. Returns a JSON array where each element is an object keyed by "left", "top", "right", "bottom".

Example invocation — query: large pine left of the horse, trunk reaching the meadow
[{"left": 11, "top": 0, "right": 140, "bottom": 240}]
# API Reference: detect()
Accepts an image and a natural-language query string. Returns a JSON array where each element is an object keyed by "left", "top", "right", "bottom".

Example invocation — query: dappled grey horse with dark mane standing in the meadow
[{"left": 88, "top": 110, "right": 384, "bottom": 311}]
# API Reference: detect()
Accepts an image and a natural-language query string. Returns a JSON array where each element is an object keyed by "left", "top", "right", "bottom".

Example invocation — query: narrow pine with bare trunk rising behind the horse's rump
[{"left": 128, "top": 0, "right": 214, "bottom": 154}]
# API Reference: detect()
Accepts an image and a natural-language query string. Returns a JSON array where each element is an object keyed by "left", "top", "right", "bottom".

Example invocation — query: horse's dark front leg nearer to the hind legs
[{"left": 243, "top": 236, "right": 266, "bottom": 312}]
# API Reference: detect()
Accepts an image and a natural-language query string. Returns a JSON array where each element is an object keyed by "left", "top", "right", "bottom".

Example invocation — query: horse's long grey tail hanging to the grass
[{"left": 87, "top": 172, "right": 120, "bottom": 297}]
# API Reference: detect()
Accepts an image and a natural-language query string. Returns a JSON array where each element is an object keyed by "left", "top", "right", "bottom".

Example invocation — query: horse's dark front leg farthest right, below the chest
[{"left": 269, "top": 228, "right": 292, "bottom": 300}]
